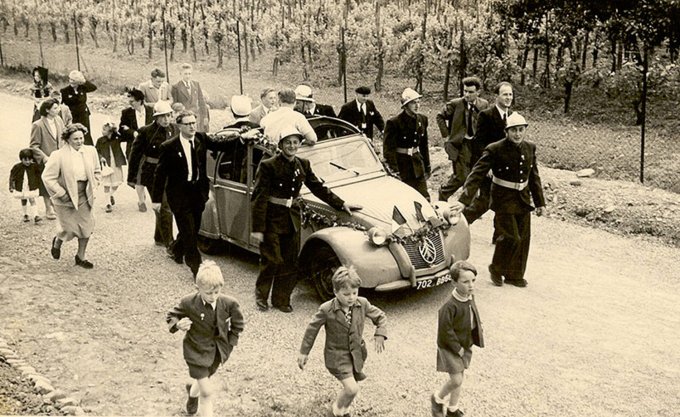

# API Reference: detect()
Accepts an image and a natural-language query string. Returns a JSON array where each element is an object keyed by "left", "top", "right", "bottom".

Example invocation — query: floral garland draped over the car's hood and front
[{"left": 296, "top": 197, "right": 450, "bottom": 245}]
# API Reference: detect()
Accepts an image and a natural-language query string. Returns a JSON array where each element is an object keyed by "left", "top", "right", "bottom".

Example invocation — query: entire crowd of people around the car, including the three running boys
[{"left": 10, "top": 64, "right": 545, "bottom": 417}]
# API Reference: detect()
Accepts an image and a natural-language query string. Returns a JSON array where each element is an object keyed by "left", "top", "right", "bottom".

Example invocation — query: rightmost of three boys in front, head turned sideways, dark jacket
[{"left": 430, "top": 261, "right": 484, "bottom": 417}]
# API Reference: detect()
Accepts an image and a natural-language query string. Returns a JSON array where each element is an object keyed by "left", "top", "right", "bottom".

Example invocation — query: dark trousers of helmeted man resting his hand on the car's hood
[{"left": 255, "top": 232, "right": 299, "bottom": 307}]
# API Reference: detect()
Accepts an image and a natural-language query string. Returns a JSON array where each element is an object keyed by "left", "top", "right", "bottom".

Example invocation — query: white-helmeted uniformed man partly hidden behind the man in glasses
[{"left": 127, "top": 101, "right": 177, "bottom": 248}]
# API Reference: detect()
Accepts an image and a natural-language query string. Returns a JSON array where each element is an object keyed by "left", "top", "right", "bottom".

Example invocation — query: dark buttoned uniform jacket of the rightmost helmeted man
[{"left": 459, "top": 139, "right": 545, "bottom": 214}]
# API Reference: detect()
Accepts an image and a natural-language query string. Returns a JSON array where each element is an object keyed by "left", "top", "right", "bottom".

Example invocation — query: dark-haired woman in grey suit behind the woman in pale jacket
[{"left": 29, "top": 98, "right": 64, "bottom": 220}]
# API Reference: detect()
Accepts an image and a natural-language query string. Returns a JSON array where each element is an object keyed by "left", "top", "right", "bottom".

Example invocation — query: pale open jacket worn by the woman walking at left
[{"left": 42, "top": 145, "right": 101, "bottom": 208}]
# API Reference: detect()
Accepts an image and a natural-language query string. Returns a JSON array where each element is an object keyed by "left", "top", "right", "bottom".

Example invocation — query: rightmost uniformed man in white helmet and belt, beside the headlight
[{"left": 459, "top": 113, "right": 545, "bottom": 287}]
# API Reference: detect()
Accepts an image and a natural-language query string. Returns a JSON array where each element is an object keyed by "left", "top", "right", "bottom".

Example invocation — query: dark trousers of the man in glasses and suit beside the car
[{"left": 171, "top": 202, "right": 204, "bottom": 277}]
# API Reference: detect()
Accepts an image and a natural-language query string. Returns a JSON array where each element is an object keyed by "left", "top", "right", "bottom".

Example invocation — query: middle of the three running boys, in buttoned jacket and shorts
[{"left": 298, "top": 266, "right": 387, "bottom": 417}]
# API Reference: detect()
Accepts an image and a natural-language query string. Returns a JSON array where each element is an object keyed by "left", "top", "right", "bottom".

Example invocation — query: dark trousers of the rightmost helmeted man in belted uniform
[{"left": 490, "top": 212, "right": 531, "bottom": 281}]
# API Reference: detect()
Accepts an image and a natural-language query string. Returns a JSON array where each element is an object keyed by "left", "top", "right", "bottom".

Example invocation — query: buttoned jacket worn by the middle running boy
[{"left": 300, "top": 297, "right": 387, "bottom": 372}]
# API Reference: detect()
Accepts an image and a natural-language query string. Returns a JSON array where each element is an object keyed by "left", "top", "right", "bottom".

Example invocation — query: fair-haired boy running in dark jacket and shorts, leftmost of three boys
[{"left": 166, "top": 261, "right": 244, "bottom": 417}]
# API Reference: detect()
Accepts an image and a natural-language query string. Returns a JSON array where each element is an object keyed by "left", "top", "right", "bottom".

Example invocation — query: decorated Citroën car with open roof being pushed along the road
[{"left": 199, "top": 117, "right": 470, "bottom": 299}]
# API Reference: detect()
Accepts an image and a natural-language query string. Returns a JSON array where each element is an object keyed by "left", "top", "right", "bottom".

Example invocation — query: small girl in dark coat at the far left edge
[{"left": 9, "top": 148, "right": 42, "bottom": 224}]
